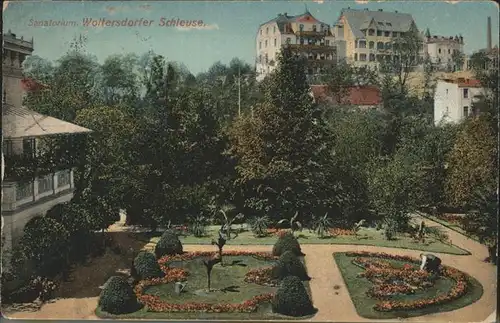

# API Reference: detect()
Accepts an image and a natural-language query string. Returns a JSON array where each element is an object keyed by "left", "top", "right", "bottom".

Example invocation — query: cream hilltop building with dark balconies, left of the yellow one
[{"left": 255, "top": 10, "right": 337, "bottom": 81}]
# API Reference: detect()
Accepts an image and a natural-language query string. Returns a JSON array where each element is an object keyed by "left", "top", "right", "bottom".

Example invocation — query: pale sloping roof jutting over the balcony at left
[{"left": 2, "top": 105, "right": 92, "bottom": 138}]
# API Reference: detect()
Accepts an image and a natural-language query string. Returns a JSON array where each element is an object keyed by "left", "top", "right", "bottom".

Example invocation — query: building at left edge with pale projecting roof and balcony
[{"left": 2, "top": 32, "right": 90, "bottom": 265}]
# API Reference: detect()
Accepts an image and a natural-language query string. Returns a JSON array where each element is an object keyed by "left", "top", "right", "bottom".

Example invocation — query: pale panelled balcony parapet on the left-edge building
[{"left": 2, "top": 169, "right": 74, "bottom": 214}]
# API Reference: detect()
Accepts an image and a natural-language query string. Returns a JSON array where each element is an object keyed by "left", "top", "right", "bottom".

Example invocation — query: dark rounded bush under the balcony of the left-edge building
[{"left": 13, "top": 216, "right": 69, "bottom": 278}]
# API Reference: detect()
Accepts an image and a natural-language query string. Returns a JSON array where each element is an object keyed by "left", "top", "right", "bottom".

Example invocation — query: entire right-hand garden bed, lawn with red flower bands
[{"left": 333, "top": 252, "right": 483, "bottom": 319}]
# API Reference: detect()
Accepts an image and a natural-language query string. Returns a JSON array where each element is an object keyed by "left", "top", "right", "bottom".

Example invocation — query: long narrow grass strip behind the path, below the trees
[{"left": 138, "top": 226, "right": 470, "bottom": 255}]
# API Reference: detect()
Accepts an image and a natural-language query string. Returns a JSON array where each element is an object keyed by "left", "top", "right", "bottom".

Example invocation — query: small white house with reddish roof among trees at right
[{"left": 434, "top": 78, "right": 484, "bottom": 125}]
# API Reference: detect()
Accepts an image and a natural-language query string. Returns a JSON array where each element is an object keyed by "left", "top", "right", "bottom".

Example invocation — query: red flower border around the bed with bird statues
[{"left": 134, "top": 251, "right": 277, "bottom": 313}]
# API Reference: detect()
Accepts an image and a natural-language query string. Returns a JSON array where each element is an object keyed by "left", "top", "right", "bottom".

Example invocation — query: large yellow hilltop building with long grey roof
[{"left": 333, "top": 8, "right": 423, "bottom": 68}]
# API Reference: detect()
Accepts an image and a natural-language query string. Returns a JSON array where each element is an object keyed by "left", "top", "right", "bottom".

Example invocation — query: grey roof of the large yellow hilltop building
[{"left": 341, "top": 8, "right": 414, "bottom": 38}]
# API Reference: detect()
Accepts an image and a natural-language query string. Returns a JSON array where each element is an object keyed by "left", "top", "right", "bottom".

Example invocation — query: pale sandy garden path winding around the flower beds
[{"left": 3, "top": 219, "right": 497, "bottom": 322}]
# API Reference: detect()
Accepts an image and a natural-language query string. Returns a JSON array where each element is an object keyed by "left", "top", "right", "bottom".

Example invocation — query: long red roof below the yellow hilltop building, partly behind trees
[{"left": 311, "top": 85, "right": 382, "bottom": 106}]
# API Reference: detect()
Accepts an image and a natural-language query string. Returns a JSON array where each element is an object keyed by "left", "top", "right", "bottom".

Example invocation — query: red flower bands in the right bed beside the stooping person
[{"left": 346, "top": 252, "right": 469, "bottom": 312}]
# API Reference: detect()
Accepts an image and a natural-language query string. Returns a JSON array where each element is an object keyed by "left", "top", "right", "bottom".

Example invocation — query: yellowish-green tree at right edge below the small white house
[{"left": 445, "top": 117, "right": 498, "bottom": 207}]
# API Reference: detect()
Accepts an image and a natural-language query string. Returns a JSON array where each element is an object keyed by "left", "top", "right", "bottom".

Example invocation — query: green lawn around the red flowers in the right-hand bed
[{"left": 333, "top": 253, "right": 483, "bottom": 319}]
